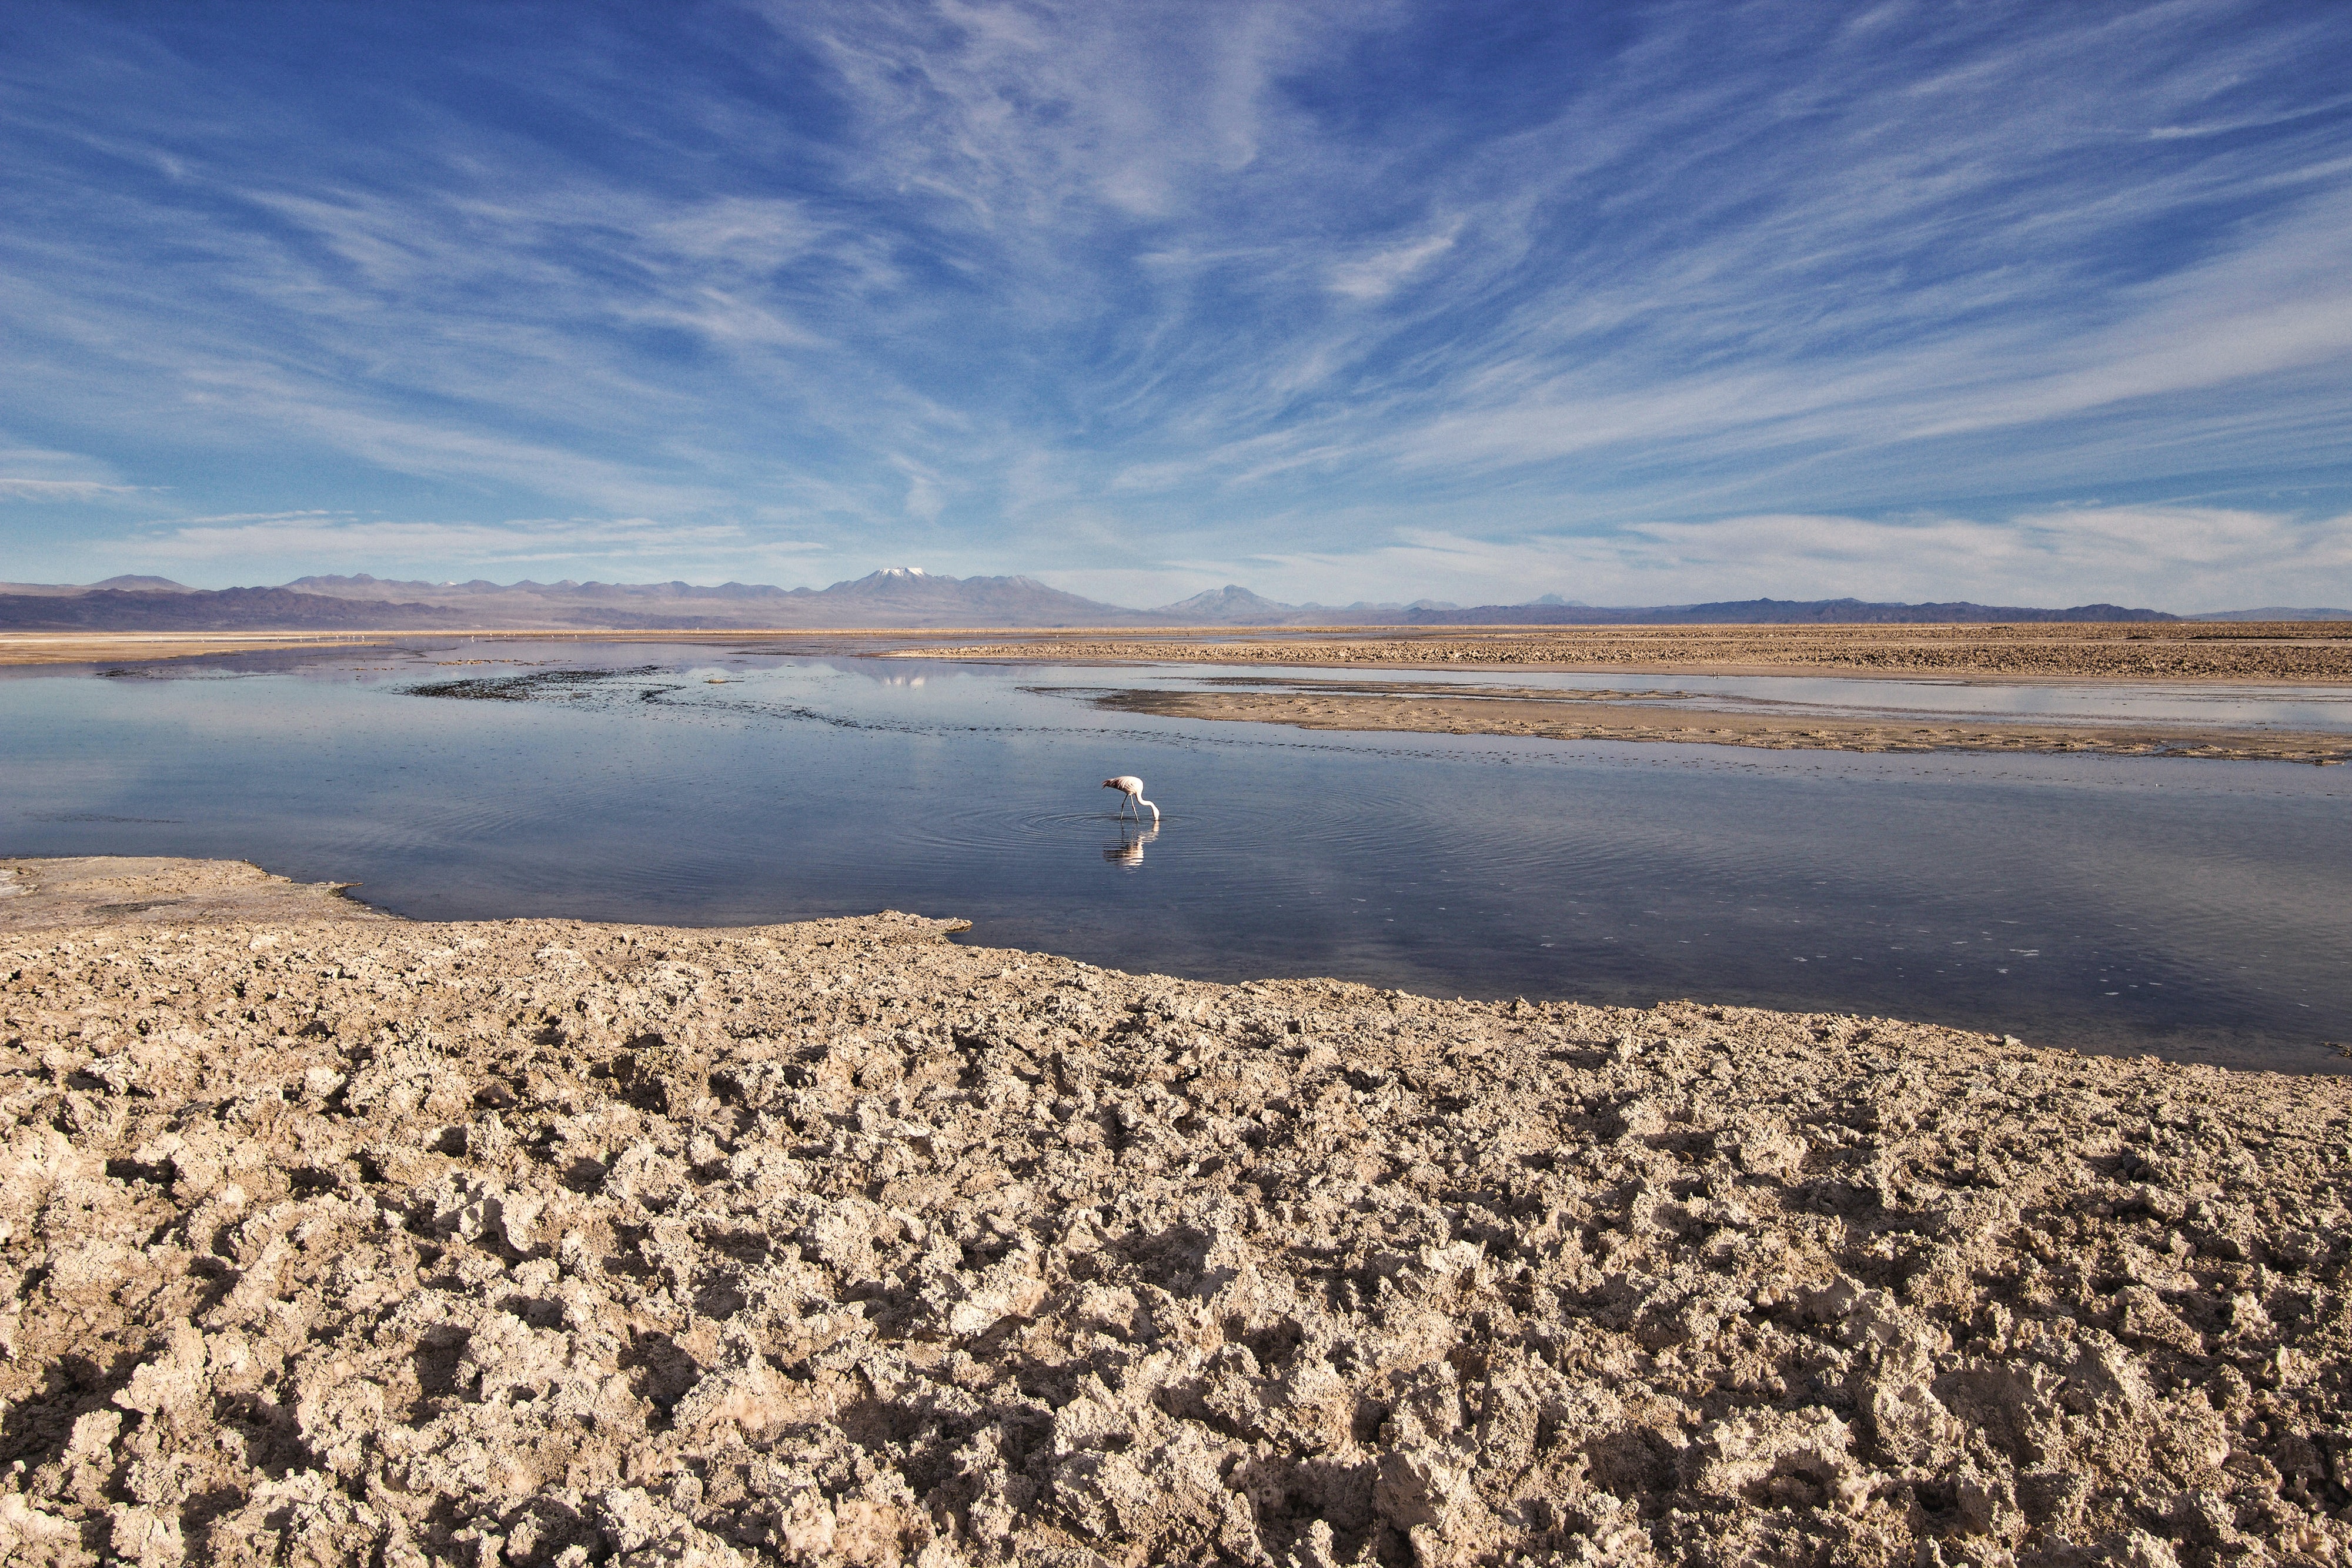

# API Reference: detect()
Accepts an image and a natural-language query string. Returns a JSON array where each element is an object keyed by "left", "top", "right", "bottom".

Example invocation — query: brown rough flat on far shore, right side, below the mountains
[{"left": 908, "top": 621, "right": 2352, "bottom": 682}]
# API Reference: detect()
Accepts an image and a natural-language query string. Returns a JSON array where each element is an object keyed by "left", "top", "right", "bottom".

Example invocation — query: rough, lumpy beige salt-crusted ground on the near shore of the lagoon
[{"left": 0, "top": 862, "right": 2352, "bottom": 1568}]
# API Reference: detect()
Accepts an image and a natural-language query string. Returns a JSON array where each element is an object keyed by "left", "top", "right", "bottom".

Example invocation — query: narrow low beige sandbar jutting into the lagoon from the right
[{"left": 1094, "top": 687, "right": 2352, "bottom": 767}]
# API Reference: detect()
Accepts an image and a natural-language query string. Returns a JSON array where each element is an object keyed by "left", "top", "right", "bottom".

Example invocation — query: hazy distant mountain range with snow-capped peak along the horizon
[{"left": 0, "top": 567, "right": 2352, "bottom": 633}]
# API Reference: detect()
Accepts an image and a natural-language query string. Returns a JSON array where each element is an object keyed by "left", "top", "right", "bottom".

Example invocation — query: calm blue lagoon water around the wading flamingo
[{"left": 0, "top": 644, "right": 2352, "bottom": 1072}]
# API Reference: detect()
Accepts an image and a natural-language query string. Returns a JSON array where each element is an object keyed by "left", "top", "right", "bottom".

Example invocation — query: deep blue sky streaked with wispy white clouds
[{"left": 0, "top": 0, "right": 2352, "bottom": 609}]
